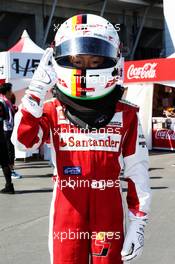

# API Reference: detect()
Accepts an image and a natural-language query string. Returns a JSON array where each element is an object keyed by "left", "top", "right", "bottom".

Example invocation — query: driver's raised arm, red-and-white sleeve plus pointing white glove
[{"left": 12, "top": 48, "right": 56, "bottom": 150}]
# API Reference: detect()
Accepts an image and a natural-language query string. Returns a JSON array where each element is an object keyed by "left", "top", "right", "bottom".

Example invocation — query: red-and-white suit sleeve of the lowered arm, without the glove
[{"left": 123, "top": 113, "right": 151, "bottom": 218}]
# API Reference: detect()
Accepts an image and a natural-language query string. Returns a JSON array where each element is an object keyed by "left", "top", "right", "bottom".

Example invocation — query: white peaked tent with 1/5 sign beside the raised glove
[{"left": 0, "top": 30, "right": 44, "bottom": 100}]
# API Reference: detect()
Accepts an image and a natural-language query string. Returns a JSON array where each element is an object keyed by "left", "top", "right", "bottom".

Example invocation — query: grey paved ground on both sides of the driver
[{"left": 0, "top": 152, "right": 175, "bottom": 264}]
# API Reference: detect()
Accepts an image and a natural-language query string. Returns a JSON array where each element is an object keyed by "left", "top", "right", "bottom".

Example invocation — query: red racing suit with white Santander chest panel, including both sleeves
[{"left": 13, "top": 99, "right": 150, "bottom": 264}]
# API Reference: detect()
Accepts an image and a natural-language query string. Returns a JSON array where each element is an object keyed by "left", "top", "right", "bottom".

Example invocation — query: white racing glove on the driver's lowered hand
[{"left": 121, "top": 217, "right": 147, "bottom": 261}]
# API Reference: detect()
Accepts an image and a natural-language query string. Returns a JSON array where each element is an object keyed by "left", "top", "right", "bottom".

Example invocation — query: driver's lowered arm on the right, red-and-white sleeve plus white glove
[{"left": 121, "top": 113, "right": 151, "bottom": 261}]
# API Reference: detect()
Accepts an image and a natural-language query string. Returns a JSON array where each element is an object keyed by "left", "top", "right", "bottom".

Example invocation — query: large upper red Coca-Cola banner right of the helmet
[{"left": 124, "top": 58, "right": 175, "bottom": 83}]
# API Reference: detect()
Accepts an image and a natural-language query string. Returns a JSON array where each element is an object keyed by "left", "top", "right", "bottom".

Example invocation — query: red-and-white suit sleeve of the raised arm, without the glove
[{"left": 11, "top": 105, "right": 50, "bottom": 151}]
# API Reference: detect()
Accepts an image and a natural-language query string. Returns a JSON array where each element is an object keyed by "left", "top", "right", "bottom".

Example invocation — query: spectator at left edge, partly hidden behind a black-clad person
[{"left": 0, "top": 83, "right": 22, "bottom": 179}]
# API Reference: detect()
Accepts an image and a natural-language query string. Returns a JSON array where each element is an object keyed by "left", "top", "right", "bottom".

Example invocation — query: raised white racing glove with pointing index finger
[{"left": 22, "top": 48, "right": 57, "bottom": 118}]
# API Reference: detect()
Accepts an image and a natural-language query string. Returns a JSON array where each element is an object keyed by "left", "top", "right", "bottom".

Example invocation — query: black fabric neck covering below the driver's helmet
[{"left": 57, "top": 85, "right": 123, "bottom": 130}]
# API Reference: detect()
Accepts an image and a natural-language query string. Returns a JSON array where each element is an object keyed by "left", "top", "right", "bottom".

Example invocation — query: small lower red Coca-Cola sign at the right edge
[{"left": 153, "top": 129, "right": 175, "bottom": 150}]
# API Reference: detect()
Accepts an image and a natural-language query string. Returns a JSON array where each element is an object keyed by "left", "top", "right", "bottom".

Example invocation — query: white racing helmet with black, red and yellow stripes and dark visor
[{"left": 55, "top": 14, "right": 123, "bottom": 99}]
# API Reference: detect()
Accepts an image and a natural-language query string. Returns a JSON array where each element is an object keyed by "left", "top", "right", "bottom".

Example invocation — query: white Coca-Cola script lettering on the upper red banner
[{"left": 127, "top": 62, "right": 157, "bottom": 80}]
